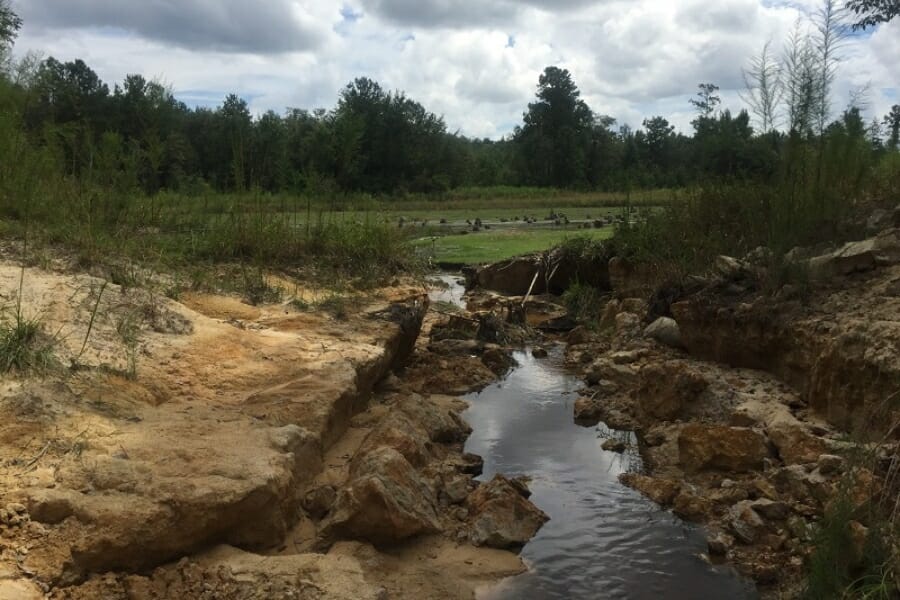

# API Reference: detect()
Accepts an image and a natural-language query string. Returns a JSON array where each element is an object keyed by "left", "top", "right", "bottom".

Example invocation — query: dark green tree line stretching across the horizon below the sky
[{"left": 0, "top": 0, "right": 900, "bottom": 195}]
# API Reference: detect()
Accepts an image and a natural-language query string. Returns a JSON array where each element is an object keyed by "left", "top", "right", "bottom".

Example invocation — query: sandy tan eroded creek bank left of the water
[{"left": 0, "top": 265, "right": 545, "bottom": 599}]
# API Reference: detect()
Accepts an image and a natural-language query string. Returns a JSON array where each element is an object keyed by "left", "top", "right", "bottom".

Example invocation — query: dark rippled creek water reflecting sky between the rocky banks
[{"left": 435, "top": 278, "right": 756, "bottom": 600}]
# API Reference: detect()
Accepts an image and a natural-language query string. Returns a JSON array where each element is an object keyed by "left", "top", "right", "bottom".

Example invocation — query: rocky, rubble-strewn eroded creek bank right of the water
[{"left": 468, "top": 216, "right": 900, "bottom": 597}]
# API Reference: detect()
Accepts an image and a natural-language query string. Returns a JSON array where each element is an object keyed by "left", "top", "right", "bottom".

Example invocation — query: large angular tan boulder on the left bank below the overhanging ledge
[{"left": 321, "top": 448, "right": 440, "bottom": 544}]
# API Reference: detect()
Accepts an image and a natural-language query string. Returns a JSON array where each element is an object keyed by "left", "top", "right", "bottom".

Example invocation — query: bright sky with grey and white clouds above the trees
[{"left": 12, "top": 0, "right": 900, "bottom": 138}]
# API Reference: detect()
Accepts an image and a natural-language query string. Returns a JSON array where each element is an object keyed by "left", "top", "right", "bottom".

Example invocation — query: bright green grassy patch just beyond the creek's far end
[{"left": 413, "top": 227, "right": 613, "bottom": 264}]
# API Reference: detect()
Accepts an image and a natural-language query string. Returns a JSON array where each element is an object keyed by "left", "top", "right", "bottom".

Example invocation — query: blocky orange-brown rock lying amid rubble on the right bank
[{"left": 678, "top": 423, "right": 770, "bottom": 473}]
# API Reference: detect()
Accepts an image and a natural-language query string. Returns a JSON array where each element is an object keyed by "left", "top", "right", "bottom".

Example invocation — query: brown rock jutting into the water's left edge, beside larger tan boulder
[{"left": 466, "top": 475, "right": 549, "bottom": 549}]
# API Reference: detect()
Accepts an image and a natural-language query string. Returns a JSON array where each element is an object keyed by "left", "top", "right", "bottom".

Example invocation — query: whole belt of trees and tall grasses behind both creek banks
[{"left": 0, "top": 0, "right": 900, "bottom": 284}]
